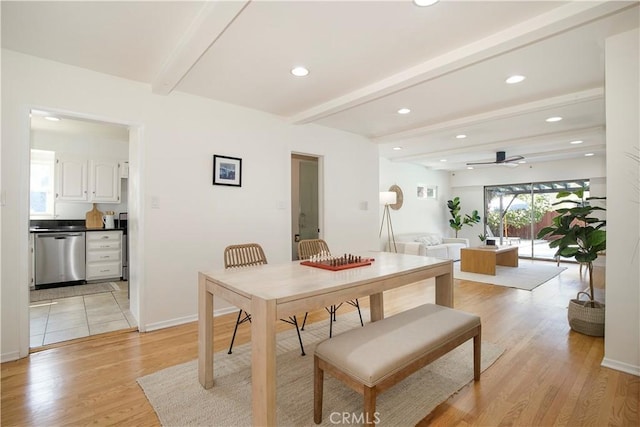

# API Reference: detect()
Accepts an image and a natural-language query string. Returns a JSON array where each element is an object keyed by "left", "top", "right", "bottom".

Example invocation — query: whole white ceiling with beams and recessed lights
[{"left": 1, "top": 0, "right": 640, "bottom": 170}]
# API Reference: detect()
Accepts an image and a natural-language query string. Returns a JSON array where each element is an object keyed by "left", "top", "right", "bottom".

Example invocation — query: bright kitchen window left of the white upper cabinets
[{"left": 29, "top": 150, "right": 56, "bottom": 218}]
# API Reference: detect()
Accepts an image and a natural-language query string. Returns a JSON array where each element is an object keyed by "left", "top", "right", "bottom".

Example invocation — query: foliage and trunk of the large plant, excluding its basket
[{"left": 538, "top": 190, "right": 607, "bottom": 304}]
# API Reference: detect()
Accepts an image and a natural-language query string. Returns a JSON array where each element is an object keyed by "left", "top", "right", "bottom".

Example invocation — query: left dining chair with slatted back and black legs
[{"left": 224, "top": 243, "right": 306, "bottom": 356}]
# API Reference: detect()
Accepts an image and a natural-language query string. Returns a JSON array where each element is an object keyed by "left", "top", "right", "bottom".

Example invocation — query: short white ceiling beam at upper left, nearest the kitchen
[{"left": 151, "top": 0, "right": 250, "bottom": 95}]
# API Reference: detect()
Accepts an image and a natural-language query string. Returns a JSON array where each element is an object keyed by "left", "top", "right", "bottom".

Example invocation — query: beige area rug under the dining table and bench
[{"left": 138, "top": 312, "right": 503, "bottom": 427}]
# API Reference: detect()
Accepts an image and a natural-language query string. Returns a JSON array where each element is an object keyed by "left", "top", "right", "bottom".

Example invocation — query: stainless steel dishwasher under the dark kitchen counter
[{"left": 35, "top": 232, "right": 86, "bottom": 288}]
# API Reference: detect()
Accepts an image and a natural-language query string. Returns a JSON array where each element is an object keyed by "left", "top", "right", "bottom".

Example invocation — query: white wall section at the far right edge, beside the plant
[{"left": 603, "top": 29, "right": 640, "bottom": 375}]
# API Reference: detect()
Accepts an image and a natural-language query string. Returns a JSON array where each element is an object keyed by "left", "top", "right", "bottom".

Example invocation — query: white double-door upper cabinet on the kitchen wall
[{"left": 56, "top": 154, "right": 120, "bottom": 203}]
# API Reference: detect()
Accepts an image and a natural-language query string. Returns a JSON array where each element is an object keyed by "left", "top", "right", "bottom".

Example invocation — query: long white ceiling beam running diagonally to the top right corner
[{"left": 289, "top": 1, "right": 634, "bottom": 124}]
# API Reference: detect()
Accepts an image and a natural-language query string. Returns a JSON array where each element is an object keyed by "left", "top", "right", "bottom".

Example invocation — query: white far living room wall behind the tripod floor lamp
[{"left": 380, "top": 158, "right": 450, "bottom": 249}]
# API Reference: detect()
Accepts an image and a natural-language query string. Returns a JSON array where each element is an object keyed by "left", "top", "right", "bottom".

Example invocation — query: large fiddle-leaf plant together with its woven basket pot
[{"left": 538, "top": 190, "right": 607, "bottom": 336}]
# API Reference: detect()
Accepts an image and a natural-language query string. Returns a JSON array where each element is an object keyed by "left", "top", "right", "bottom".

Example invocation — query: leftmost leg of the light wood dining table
[{"left": 198, "top": 273, "right": 213, "bottom": 389}]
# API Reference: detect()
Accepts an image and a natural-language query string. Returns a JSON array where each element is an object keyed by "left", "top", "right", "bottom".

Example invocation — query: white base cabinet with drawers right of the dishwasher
[{"left": 86, "top": 230, "right": 122, "bottom": 281}]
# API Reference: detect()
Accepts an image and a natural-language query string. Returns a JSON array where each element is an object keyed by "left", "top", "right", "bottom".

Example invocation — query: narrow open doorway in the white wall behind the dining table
[{"left": 291, "top": 154, "right": 321, "bottom": 260}]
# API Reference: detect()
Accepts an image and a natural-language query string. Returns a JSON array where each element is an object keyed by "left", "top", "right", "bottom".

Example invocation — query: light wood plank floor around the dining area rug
[{"left": 0, "top": 261, "right": 640, "bottom": 426}]
